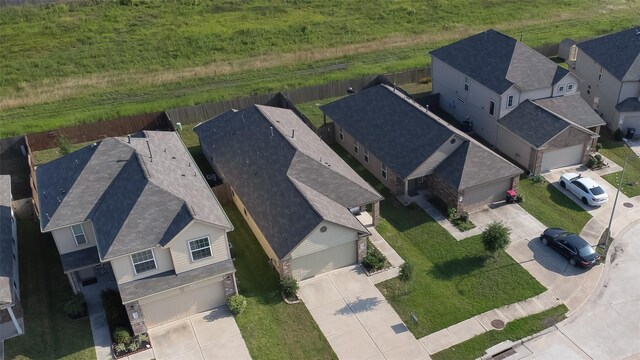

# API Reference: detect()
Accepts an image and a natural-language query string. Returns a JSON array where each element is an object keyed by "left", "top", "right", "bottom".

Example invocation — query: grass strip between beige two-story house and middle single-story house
[{"left": 224, "top": 204, "right": 337, "bottom": 359}]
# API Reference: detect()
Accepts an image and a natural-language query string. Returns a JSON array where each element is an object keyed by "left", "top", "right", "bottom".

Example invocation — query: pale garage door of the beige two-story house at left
[{"left": 140, "top": 279, "right": 226, "bottom": 328}]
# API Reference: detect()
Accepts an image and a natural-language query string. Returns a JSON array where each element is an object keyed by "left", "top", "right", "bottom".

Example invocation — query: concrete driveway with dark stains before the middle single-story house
[{"left": 298, "top": 266, "right": 429, "bottom": 359}]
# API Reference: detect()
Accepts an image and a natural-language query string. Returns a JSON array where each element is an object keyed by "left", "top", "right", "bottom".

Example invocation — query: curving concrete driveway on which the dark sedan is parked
[{"left": 470, "top": 204, "right": 603, "bottom": 312}]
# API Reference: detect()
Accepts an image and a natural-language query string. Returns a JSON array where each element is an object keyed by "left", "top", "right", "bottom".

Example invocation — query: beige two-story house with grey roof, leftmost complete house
[{"left": 36, "top": 131, "right": 236, "bottom": 334}]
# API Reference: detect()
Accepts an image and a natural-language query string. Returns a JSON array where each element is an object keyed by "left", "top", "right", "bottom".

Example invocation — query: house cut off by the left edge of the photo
[{"left": 0, "top": 175, "right": 24, "bottom": 342}]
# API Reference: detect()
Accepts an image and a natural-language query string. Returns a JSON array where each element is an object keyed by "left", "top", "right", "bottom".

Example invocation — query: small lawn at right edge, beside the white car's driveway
[{"left": 599, "top": 128, "right": 640, "bottom": 197}]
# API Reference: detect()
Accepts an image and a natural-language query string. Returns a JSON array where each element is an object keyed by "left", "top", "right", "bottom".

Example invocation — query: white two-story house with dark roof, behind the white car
[{"left": 431, "top": 30, "right": 604, "bottom": 173}]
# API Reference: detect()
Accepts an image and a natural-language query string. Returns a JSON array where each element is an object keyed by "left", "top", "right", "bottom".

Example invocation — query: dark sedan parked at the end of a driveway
[{"left": 540, "top": 228, "right": 600, "bottom": 268}]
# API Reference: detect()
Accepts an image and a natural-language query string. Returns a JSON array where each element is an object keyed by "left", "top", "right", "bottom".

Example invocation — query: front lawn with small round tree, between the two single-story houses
[{"left": 333, "top": 145, "right": 545, "bottom": 338}]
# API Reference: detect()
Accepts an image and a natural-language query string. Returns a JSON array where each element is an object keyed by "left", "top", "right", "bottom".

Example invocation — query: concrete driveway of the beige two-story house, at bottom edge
[{"left": 149, "top": 307, "right": 251, "bottom": 360}]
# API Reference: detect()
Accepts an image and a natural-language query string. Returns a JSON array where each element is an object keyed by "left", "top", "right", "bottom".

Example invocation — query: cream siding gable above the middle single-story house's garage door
[{"left": 291, "top": 221, "right": 358, "bottom": 259}]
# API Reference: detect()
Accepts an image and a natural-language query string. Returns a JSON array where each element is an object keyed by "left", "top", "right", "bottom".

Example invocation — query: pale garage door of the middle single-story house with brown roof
[{"left": 291, "top": 241, "right": 358, "bottom": 280}]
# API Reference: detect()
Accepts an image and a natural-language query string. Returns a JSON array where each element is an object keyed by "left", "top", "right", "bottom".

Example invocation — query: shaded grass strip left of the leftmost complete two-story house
[{"left": 5, "top": 220, "right": 96, "bottom": 360}]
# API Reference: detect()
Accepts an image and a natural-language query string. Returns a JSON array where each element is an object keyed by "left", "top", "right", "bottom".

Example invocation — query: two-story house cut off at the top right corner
[{"left": 574, "top": 27, "right": 640, "bottom": 131}]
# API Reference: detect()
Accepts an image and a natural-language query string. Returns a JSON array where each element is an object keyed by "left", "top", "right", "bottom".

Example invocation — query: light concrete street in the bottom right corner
[{"left": 511, "top": 222, "right": 640, "bottom": 360}]
